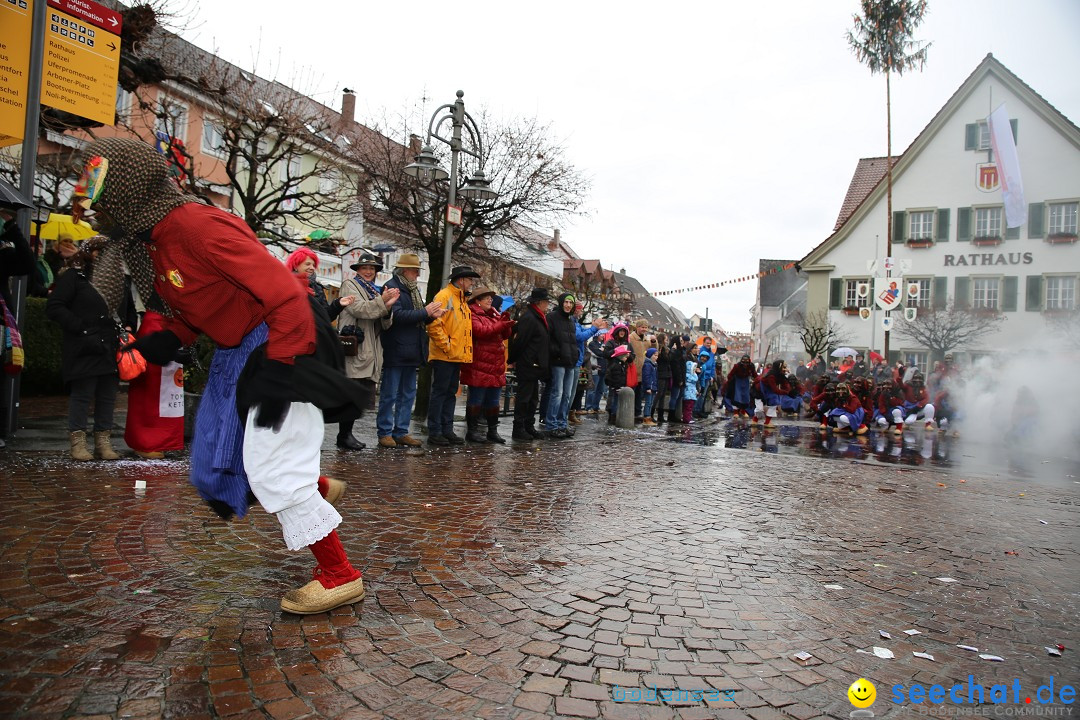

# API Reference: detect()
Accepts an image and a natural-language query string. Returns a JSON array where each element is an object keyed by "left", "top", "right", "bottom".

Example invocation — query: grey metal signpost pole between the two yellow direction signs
[{"left": 4, "top": 0, "right": 49, "bottom": 435}]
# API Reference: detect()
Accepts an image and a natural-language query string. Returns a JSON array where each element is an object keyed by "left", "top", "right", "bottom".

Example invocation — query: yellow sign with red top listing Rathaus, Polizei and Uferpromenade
[{"left": 41, "top": 0, "right": 121, "bottom": 125}]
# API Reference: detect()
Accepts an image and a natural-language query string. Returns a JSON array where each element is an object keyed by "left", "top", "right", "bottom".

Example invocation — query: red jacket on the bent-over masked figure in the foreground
[{"left": 147, "top": 203, "right": 315, "bottom": 365}]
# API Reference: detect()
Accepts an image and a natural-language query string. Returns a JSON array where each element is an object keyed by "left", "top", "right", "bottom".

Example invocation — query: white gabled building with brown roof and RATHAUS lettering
[{"left": 800, "top": 55, "right": 1080, "bottom": 368}]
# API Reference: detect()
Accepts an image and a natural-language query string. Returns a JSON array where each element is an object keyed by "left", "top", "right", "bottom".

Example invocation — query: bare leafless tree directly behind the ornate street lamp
[{"left": 350, "top": 116, "right": 589, "bottom": 299}]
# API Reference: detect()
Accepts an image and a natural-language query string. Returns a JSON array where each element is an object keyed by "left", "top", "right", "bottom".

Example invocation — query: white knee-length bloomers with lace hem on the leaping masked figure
[{"left": 244, "top": 403, "right": 341, "bottom": 551}]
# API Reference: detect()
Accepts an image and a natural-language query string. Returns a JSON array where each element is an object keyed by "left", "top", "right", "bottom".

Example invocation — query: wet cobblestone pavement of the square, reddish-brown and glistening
[{"left": 0, "top": 400, "right": 1080, "bottom": 720}]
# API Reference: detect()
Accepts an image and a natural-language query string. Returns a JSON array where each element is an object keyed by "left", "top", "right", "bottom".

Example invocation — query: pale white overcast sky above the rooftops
[{"left": 183, "top": 0, "right": 1080, "bottom": 330}]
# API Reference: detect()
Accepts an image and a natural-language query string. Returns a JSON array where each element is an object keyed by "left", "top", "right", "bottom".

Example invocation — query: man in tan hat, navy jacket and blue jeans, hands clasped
[{"left": 375, "top": 253, "right": 446, "bottom": 448}]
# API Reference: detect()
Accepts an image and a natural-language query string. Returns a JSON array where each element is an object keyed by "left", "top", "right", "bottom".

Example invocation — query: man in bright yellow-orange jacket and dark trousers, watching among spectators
[{"left": 428, "top": 266, "right": 480, "bottom": 445}]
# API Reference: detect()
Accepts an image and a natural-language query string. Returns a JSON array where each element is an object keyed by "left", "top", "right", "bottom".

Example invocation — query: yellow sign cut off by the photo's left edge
[{"left": 0, "top": 0, "right": 33, "bottom": 148}]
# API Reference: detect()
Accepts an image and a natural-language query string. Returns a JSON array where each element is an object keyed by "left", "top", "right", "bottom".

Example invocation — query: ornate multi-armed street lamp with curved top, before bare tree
[{"left": 404, "top": 90, "right": 499, "bottom": 285}]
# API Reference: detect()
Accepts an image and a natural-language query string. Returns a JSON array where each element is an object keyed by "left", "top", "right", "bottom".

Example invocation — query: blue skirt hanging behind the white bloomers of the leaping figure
[{"left": 191, "top": 323, "right": 268, "bottom": 517}]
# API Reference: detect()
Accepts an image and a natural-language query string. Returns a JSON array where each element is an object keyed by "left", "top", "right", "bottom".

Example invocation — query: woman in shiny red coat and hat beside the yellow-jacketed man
[{"left": 461, "top": 287, "right": 514, "bottom": 444}]
